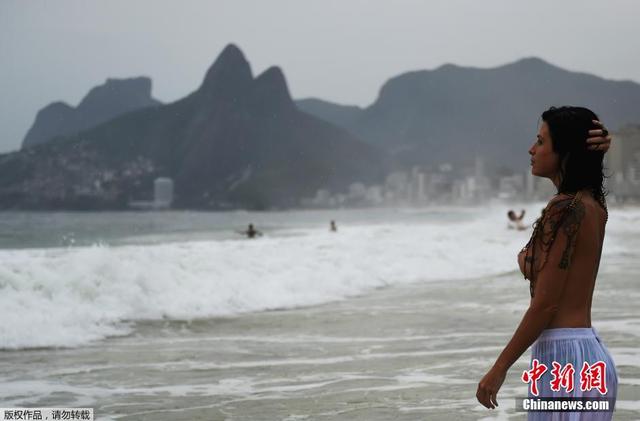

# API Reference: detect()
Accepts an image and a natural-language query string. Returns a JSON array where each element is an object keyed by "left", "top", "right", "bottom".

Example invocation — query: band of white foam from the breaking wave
[{"left": 0, "top": 207, "right": 639, "bottom": 348}]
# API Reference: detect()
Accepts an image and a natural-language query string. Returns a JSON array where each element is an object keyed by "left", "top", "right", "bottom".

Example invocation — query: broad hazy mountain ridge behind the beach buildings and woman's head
[{"left": 297, "top": 58, "right": 640, "bottom": 170}]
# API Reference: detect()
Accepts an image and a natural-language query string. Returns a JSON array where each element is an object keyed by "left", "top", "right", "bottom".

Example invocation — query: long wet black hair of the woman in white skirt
[{"left": 542, "top": 106, "right": 607, "bottom": 208}]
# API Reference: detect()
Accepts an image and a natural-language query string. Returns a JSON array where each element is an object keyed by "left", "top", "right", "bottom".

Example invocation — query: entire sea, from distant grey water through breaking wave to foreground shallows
[{"left": 0, "top": 203, "right": 640, "bottom": 420}]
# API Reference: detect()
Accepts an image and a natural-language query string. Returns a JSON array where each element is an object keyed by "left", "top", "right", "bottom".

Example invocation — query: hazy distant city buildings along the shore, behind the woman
[{"left": 301, "top": 144, "right": 640, "bottom": 208}]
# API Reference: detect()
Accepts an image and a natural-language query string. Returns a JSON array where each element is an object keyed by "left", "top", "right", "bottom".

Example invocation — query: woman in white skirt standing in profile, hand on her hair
[{"left": 476, "top": 107, "right": 617, "bottom": 420}]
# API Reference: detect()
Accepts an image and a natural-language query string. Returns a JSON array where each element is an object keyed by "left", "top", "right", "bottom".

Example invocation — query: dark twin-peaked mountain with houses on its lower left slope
[{"left": 0, "top": 45, "right": 386, "bottom": 209}]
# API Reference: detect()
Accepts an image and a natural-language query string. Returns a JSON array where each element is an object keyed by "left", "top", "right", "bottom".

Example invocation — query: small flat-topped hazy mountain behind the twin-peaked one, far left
[{"left": 22, "top": 77, "right": 160, "bottom": 148}]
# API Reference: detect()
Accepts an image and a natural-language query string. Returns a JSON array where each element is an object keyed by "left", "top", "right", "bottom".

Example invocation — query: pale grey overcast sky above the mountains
[{"left": 0, "top": 0, "right": 640, "bottom": 152}]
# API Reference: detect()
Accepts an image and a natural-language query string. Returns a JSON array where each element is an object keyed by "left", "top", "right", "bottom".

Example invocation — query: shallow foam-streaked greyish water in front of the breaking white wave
[{"left": 0, "top": 260, "right": 640, "bottom": 420}]
